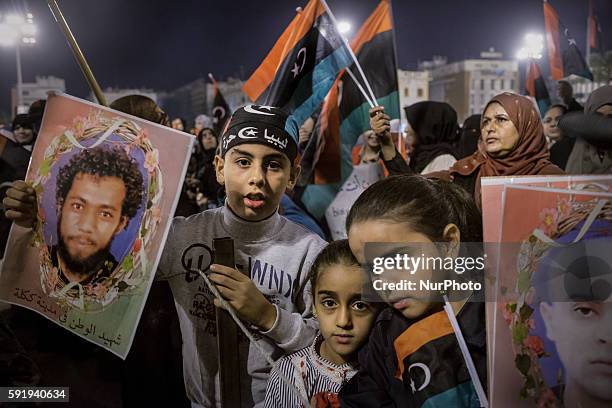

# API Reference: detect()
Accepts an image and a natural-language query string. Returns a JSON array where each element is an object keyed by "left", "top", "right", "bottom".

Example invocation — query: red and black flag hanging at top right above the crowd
[{"left": 544, "top": 1, "right": 593, "bottom": 81}]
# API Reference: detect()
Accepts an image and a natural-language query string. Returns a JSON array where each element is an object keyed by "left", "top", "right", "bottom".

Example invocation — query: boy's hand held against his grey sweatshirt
[{"left": 209, "top": 264, "right": 276, "bottom": 331}]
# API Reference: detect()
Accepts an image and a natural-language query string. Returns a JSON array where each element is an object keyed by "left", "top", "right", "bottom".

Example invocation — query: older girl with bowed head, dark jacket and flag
[{"left": 340, "top": 175, "right": 487, "bottom": 407}]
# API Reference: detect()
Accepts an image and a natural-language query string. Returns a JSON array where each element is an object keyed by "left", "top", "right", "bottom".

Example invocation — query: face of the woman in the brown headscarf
[{"left": 481, "top": 102, "right": 520, "bottom": 158}]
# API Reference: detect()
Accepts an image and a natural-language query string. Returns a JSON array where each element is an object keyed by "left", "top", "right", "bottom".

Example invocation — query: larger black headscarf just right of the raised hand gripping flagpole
[{"left": 404, "top": 101, "right": 459, "bottom": 173}]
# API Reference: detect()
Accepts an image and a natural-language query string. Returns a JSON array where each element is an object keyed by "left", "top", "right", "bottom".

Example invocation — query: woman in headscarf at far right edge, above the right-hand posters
[{"left": 559, "top": 85, "right": 612, "bottom": 174}]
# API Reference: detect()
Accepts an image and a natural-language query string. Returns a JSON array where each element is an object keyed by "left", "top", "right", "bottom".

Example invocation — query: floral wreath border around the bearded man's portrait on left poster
[{"left": 32, "top": 110, "right": 163, "bottom": 312}]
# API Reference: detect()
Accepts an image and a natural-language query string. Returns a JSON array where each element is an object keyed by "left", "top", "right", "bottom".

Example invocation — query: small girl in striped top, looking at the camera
[{"left": 265, "top": 240, "right": 377, "bottom": 408}]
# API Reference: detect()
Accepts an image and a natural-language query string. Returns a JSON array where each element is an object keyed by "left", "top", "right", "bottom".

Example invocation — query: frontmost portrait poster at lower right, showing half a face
[{"left": 487, "top": 184, "right": 612, "bottom": 407}]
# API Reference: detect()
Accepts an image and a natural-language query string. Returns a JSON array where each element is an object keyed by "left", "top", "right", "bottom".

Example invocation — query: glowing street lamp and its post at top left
[{"left": 0, "top": 13, "right": 36, "bottom": 113}]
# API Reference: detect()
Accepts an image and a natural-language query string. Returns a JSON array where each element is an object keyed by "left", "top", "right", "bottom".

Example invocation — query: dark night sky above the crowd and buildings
[{"left": 0, "top": 0, "right": 612, "bottom": 116}]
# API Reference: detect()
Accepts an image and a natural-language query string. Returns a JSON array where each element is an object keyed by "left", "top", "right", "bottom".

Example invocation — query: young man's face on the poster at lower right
[{"left": 540, "top": 250, "right": 612, "bottom": 402}]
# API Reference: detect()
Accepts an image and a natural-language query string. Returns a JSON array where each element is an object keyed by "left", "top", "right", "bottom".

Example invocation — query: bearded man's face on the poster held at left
[{"left": 58, "top": 173, "right": 128, "bottom": 274}]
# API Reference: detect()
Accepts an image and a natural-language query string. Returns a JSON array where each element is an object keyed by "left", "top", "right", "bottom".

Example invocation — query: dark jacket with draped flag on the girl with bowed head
[{"left": 340, "top": 302, "right": 486, "bottom": 408}]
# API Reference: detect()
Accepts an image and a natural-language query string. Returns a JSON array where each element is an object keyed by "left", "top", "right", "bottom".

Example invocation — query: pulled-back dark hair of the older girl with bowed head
[{"left": 346, "top": 174, "right": 482, "bottom": 242}]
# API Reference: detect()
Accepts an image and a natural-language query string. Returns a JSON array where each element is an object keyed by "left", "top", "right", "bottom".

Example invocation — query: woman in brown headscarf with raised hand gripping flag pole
[{"left": 370, "top": 92, "right": 563, "bottom": 208}]
